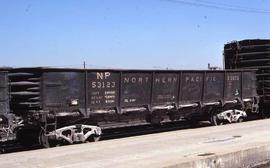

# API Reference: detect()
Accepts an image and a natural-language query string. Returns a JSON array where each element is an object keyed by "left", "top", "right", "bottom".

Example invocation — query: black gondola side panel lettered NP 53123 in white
[{"left": 87, "top": 71, "right": 120, "bottom": 109}]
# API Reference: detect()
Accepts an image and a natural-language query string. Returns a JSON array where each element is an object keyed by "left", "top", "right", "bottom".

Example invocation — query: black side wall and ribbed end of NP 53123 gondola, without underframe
[{"left": 10, "top": 69, "right": 258, "bottom": 111}]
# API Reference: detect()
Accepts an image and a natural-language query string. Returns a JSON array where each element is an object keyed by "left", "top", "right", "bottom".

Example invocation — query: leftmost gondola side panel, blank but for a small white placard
[{"left": 42, "top": 72, "right": 85, "bottom": 112}]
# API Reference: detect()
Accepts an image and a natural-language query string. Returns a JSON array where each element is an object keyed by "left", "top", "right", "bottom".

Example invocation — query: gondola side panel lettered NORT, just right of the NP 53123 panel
[{"left": 121, "top": 72, "right": 152, "bottom": 107}]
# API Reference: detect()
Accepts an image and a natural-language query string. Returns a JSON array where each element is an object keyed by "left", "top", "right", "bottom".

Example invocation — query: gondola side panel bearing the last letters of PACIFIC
[{"left": 203, "top": 72, "right": 224, "bottom": 102}]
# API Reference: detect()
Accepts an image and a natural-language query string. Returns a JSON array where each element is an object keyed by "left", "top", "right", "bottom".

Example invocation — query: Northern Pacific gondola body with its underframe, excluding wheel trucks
[{"left": 5, "top": 68, "right": 258, "bottom": 129}]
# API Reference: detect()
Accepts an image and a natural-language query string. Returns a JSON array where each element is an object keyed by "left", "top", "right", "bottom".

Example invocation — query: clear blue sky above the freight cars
[{"left": 0, "top": 0, "right": 270, "bottom": 69}]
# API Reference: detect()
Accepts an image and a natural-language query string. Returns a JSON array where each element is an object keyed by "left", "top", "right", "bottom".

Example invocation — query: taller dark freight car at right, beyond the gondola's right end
[{"left": 224, "top": 39, "right": 270, "bottom": 117}]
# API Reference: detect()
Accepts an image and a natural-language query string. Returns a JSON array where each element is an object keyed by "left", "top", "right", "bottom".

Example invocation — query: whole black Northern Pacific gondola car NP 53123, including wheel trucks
[{"left": 0, "top": 68, "right": 259, "bottom": 147}]
